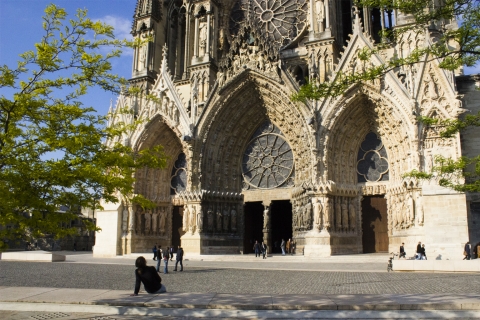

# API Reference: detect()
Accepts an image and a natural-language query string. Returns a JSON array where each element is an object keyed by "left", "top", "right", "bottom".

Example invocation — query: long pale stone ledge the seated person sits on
[{"left": 0, "top": 287, "right": 480, "bottom": 311}]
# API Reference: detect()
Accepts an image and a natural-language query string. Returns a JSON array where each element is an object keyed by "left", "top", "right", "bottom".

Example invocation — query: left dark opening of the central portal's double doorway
[{"left": 243, "top": 202, "right": 264, "bottom": 253}]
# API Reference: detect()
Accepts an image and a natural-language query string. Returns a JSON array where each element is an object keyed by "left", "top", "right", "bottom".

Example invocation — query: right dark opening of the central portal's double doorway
[{"left": 270, "top": 200, "right": 292, "bottom": 253}]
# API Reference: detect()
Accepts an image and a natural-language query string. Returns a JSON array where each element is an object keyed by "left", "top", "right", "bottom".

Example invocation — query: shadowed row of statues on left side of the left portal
[{"left": 135, "top": 207, "right": 170, "bottom": 235}]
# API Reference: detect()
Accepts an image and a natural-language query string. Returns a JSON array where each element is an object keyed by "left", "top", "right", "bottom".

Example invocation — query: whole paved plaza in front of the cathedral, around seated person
[{"left": 0, "top": 253, "right": 480, "bottom": 320}]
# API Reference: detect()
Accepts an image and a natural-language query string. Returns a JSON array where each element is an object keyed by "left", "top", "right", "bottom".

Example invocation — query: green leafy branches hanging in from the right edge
[{"left": 292, "top": 0, "right": 480, "bottom": 192}]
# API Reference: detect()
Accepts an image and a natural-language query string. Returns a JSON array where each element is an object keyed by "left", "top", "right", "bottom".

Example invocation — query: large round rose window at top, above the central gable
[{"left": 230, "top": 0, "right": 308, "bottom": 47}]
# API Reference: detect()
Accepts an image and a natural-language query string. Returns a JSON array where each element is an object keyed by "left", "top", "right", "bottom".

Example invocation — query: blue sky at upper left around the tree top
[{"left": 0, "top": 0, "right": 136, "bottom": 114}]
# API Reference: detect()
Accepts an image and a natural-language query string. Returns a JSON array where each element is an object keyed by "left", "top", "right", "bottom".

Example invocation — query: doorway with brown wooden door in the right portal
[{"left": 362, "top": 196, "right": 388, "bottom": 253}]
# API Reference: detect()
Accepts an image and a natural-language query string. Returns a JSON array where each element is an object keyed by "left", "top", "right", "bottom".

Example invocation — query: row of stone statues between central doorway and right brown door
[{"left": 293, "top": 197, "right": 357, "bottom": 232}]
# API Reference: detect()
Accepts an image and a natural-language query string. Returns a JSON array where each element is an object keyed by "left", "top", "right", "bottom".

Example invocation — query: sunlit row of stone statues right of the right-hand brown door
[{"left": 387, "top": 192, "right": 424, "bottom": 230}]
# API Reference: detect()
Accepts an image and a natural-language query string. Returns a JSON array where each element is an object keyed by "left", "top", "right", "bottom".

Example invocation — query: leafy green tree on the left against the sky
[{"left": 0, "top": 5, "right": 166, "bottom": 249}]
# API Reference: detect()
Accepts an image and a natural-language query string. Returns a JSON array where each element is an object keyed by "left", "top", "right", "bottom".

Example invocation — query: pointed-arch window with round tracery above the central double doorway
[{"left": 242, "top": 121, "right": 295, "bottom": 190}]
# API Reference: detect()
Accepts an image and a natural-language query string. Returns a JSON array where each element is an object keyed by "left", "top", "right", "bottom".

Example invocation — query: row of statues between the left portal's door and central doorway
[{"left": 183, "top": 203, "right": 237, "bottom": 234}]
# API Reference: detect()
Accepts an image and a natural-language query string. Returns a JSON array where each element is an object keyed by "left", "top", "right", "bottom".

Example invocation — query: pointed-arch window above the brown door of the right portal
[{"left": 357, "top": 132, "right": 389, "bottom": 182}]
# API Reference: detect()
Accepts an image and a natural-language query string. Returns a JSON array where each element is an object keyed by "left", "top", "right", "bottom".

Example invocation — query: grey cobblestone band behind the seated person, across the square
[{"left": 0, "top": 261, "right": 480, "bottom": 294}]
